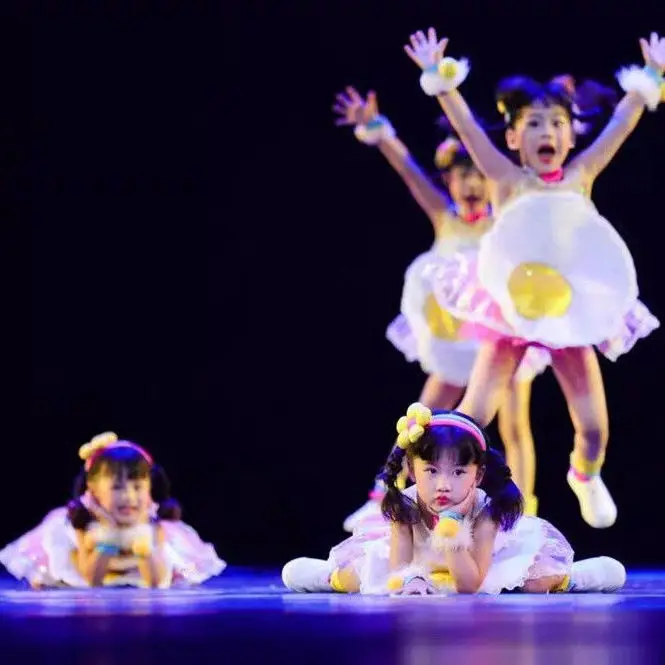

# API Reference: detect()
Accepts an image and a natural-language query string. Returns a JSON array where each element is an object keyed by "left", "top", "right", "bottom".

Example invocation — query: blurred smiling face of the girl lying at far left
[{"left": 88, "top": 471, "right": 152, "bottom": 526}]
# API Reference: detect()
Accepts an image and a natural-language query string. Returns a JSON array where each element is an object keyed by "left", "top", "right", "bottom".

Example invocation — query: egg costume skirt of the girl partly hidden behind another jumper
[{"left": 386, "top": 250, "right": 551, "bottom": 387}]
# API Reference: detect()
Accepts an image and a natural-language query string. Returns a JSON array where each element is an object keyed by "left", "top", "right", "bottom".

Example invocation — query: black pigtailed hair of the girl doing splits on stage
[{"left": 379, "top": 411, "right": 524, "bottom": 531}]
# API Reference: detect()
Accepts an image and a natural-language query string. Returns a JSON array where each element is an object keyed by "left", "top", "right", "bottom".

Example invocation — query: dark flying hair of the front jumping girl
[{"left": 496, "top": 74, "right": 618, "bottom": 134}]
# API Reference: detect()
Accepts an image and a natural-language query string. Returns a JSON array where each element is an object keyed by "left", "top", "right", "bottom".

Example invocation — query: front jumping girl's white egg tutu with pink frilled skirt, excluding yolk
[{"left": 425, "top": 191, "right": 660, "bottom": 360}]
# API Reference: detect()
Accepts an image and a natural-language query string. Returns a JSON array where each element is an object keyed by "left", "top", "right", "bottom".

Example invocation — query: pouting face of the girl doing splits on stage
[{"left": 412, "top": 451, "right": 482, "bottom": 514}]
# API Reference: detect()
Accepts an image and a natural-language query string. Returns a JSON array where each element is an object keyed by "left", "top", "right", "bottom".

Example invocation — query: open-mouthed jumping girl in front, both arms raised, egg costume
[{"left": 405, "top": 29, "right": 665, "bottom": 528}]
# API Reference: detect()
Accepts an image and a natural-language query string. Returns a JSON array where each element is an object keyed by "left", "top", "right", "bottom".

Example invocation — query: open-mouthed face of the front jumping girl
[{"left": 506, "top": 103, "right": 575, "bottom": 173}]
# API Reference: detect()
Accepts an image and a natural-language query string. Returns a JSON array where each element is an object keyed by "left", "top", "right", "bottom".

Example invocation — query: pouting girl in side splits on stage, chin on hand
[{"left": 282, "top": 404, "right": 626, "bottom": 595}]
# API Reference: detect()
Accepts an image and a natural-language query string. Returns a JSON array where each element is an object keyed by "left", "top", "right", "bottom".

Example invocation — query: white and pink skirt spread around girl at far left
[{"left": 0, "top": 508, "right": 226, "bottom": 588}]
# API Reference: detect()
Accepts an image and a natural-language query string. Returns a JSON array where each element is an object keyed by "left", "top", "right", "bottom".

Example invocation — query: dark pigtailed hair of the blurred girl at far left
[{"left": 67, "top": 446, "right": 182, "bottom": 530}]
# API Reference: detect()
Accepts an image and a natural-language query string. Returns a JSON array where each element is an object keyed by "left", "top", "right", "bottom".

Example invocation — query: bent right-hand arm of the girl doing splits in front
[{"left": 438, "top": 513, "right": 498, "bottom": 593}]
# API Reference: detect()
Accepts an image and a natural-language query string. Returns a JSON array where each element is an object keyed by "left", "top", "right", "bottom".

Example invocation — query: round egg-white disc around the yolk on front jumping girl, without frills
[{"left": 478, "top": 191, "right": 638, "bottom": 348}]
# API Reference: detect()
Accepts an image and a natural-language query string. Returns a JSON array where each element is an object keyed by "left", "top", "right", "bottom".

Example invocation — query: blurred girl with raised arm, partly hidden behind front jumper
[{"left": 333, "top": 87, "right": 549, "bottom": 532}]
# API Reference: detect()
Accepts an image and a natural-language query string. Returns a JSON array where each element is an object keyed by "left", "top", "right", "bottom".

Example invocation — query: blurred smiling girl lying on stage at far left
[{"left": 0, "top": 433, "right": 226, "bottom": 589}]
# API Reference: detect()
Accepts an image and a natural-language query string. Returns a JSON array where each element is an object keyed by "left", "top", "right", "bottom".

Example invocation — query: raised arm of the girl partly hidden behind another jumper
[{"left": 333, "top": 86, "right": 449, "bottom": 230}]
